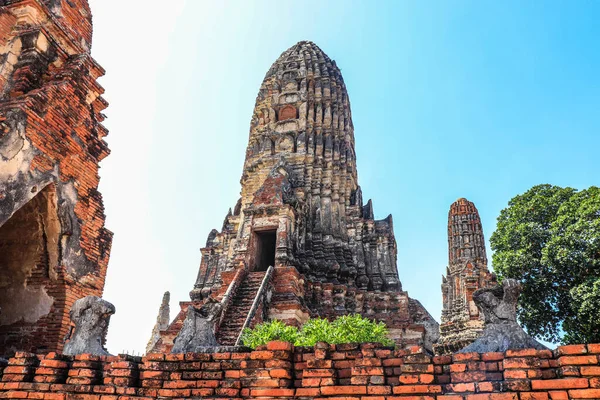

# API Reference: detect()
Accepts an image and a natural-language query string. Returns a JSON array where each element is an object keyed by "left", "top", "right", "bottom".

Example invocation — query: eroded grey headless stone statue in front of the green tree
[{"left": 459, "top": 279, "right": 546, "bottom": 353}]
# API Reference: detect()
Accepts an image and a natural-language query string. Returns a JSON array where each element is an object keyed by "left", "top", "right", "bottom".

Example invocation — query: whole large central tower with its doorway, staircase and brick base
[{"left": 154, "top": 42, "right": 437, "bottom": 351}]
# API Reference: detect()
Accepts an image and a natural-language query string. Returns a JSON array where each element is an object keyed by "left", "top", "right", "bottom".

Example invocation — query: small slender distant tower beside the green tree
[{"left": 434, "top": 198, "right": 495, "bottom": 354}]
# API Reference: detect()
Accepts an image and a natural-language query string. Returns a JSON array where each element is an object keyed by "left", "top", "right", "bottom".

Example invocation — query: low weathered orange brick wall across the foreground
[{"left": 0, "top": 342, "right": 600, "bottom": 400}]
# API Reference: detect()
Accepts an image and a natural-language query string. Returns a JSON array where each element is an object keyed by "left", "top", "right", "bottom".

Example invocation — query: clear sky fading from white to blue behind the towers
[{"left": 90, "top": 0, "right": 600, "bottom": 353}]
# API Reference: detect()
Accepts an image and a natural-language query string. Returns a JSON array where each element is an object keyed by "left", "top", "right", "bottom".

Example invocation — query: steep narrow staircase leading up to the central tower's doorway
[{"left": 217, "top": 271, "right": 266, "bottom": 346}]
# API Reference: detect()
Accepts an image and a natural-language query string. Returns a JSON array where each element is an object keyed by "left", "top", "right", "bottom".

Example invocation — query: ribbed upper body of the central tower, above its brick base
[{"left": 195, "top": 42, "right": 400, "bottom": 293}]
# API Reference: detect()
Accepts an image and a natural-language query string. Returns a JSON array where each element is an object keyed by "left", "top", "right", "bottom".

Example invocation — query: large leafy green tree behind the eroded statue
[{"left": 490, "top": 185, "right": 600, "bottom": 343}]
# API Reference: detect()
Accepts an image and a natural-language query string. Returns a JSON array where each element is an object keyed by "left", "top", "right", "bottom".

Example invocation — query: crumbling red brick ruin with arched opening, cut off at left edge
[{"left": 0, "top": 0, "right": 112, "bottom": 355}]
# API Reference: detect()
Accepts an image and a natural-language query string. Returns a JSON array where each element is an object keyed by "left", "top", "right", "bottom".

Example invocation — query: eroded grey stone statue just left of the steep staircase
[{"left": 171, "top": 297, "right": 223, "bottom": 353}]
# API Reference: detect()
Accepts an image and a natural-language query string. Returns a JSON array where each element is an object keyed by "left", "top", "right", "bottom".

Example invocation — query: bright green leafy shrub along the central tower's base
[{"left": 242, "top": 314, "right": 394, "bottom": 348}]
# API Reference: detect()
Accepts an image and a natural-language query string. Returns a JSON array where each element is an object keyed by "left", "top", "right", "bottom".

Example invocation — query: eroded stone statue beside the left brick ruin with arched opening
[{"left": 63, "top": 296, "right": 115, "bottom": 356}]
